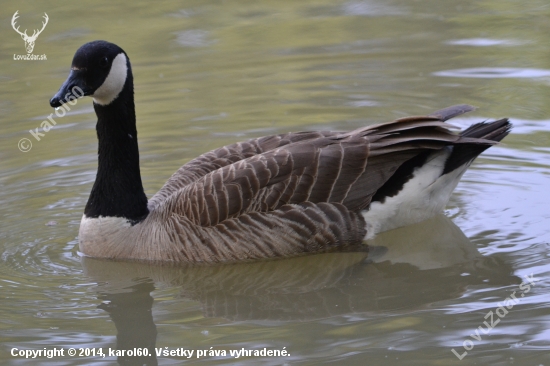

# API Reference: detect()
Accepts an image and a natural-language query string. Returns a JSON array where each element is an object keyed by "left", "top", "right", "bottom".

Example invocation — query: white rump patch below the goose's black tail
[{"left": 362, "top": 148, "right": 469, "bottom": 239}]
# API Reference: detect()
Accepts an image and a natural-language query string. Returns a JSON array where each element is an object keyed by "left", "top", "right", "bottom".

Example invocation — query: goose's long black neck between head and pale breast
[{"left": 84, "top": 68, "right": 149, "bottom": 223}]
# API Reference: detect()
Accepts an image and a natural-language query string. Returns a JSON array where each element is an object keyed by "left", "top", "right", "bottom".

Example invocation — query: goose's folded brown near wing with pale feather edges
[{"left": 153, "top": 110, "right": 476, "bottom": 226}]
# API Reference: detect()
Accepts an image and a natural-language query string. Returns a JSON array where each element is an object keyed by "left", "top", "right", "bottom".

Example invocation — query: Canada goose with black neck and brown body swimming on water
[{"left": 50, "top": 41, "right": 511, "bottom": 263}]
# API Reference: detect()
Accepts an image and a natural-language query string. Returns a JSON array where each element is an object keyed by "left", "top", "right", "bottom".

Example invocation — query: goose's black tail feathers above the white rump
[{"left": 443, "top": 118, "right": 512, "bottom": 174}]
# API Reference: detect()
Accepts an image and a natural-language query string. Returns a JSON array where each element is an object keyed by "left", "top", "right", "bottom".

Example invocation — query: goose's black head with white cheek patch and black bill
[{"left": 50, "top": 41, "right": 133, "bottom": 108}]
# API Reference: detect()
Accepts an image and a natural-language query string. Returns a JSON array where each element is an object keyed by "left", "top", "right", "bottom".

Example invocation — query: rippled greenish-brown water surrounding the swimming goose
[{"left": 0, "top": 0, "right": 550, "bottom": 365}]
